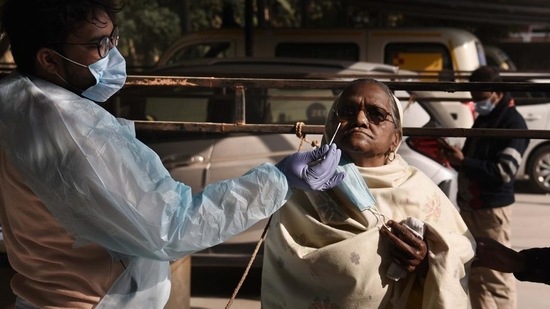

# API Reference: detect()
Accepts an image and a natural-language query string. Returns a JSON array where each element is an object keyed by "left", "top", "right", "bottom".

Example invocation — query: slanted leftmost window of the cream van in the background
[{"left": 166, "top": 42, "right": 234, "bottom": 65}]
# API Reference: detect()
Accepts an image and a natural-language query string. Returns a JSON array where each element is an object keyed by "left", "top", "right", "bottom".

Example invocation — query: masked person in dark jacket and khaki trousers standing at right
[{"left": 442, "top": 66, "right": 529, "bottom": 309}]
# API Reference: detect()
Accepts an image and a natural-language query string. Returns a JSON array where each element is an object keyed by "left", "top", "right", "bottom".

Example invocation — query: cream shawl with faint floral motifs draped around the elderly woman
[{"left": 261, "top": 155, "right": 475, "bottom": 309}]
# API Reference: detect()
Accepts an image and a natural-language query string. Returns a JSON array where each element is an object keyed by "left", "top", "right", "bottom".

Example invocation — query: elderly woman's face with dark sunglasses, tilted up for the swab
[{"left": 327, "top": 83, "right": 400, "bottom": 166}]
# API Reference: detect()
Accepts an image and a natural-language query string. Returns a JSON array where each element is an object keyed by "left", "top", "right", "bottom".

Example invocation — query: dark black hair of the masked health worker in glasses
[{"left": 0, "top": 0, "right": 124, "bottom": 73}]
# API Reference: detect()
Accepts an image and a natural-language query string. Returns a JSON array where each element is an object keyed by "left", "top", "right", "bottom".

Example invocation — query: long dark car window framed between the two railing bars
[{"left": 108, "top": 87, "right": 335, "bottom": 124}]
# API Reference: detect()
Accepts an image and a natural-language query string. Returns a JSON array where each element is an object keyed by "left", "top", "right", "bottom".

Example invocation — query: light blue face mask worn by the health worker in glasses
[{"left": 55, "top": 47, "right": 126, "bottom": 102}]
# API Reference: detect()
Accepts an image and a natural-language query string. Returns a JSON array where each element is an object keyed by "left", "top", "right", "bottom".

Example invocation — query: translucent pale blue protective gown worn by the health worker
[{"left": 0, "top": 72, "right": 291, "bottom": 308}]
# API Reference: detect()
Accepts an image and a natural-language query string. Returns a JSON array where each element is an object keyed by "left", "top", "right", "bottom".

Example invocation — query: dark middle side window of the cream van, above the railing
[{"left": 275, "top": 42, "right": 359, "bottom": 61}]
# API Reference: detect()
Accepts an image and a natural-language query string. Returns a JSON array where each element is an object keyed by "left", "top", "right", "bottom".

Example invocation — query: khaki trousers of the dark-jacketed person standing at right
[{"left": 460, "top": 206, "right": 517, "bottom": 309}]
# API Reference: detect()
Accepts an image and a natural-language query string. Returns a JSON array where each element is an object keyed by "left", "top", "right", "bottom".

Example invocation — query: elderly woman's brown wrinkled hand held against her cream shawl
[{"left": 380, "top": 220, "right": 428, "bottom": 275}]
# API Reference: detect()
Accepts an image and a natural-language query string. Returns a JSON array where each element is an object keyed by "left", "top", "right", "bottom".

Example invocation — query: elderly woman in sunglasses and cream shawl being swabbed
[{"left": 261, "top": 79, "right": 475, "bottom": 309}]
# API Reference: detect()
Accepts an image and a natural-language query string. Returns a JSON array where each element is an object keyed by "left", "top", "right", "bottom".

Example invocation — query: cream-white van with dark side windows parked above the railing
[{"left": 157, "top": 28, "right": 486, "bottom": 80}]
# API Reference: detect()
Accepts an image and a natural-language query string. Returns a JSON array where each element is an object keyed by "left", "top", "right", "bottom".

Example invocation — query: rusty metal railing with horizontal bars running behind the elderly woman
[{"left": 125, "top": 74, "right": 550, "bottom": 139}]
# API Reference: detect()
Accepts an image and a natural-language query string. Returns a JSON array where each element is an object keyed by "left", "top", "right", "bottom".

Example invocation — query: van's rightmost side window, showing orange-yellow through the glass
[{"left": 384, "top": 42, "right": 453, "bottom": 71}]
